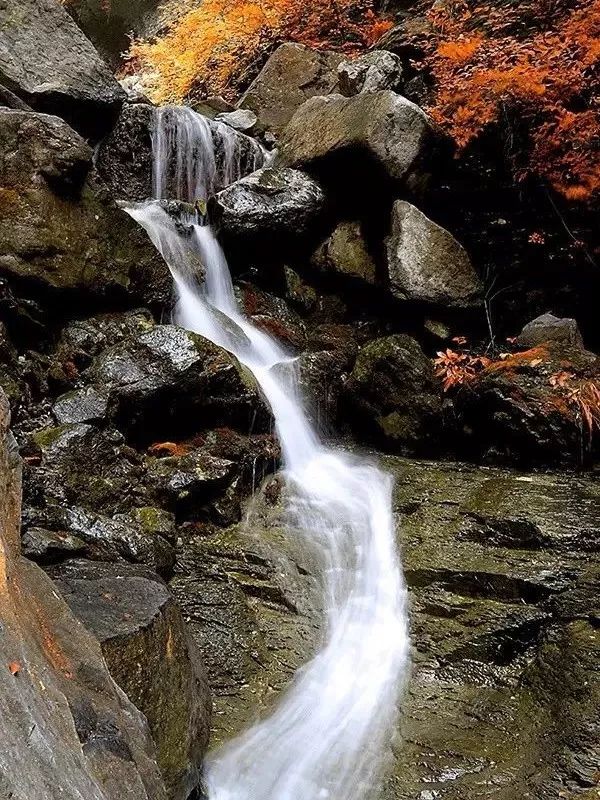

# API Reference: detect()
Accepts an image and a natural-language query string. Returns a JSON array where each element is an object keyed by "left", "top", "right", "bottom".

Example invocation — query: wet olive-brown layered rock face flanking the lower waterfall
[{"left": 173, "top": 457, "right": 600, "bottom": 800}]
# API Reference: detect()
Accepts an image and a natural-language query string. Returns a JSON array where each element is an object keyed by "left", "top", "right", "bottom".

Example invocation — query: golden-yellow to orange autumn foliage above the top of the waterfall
[{"left": 129, "top": 0, "right": 389, "bottom": 103}]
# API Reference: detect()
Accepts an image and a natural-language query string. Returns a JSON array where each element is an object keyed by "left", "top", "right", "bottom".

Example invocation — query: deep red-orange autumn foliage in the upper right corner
[{"left": 424, "top": 0, "right": 600, "bottom": 201}]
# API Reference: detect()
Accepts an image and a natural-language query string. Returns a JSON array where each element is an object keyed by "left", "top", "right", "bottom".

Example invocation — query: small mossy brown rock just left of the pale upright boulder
[{"left": 311, "top": 222, "right": 377, "bottom": 286}]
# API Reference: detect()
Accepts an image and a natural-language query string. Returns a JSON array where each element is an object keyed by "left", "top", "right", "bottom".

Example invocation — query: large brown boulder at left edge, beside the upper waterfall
[{"left": 0, "top": 109, "right": 171, "bottom": 310}]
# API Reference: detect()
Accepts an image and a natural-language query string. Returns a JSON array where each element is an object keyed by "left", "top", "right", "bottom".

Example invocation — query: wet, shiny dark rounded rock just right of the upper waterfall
[{"left": 211, "top": 167, "right": 325, "bottom": 253}]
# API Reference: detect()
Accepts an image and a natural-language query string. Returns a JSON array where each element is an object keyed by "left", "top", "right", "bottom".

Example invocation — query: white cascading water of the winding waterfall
[{"left": 128, "top": 110, "right": 408, "bottom": 800}]
